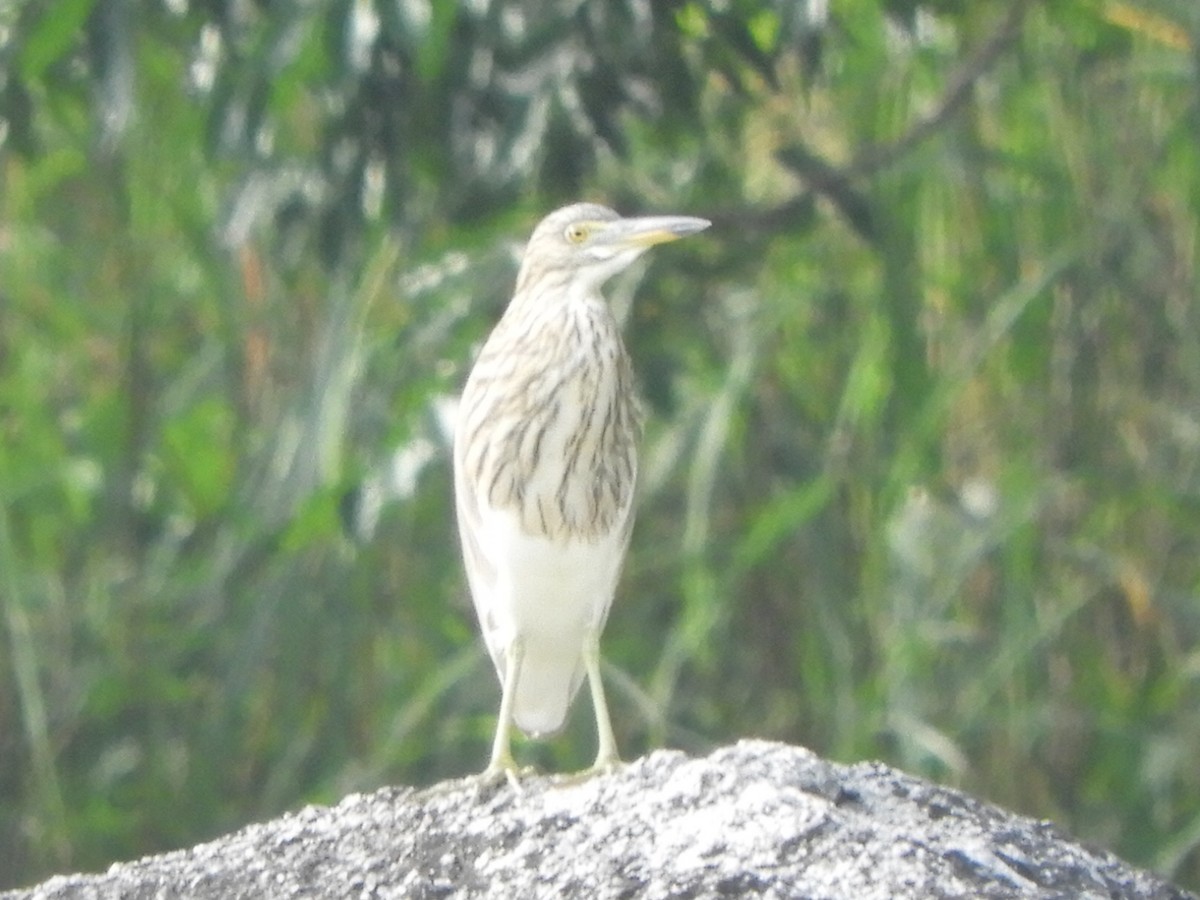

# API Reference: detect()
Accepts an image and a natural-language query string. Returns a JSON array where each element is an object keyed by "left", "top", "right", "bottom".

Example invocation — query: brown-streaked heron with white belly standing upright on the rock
[{"left": 454, "top": 203, "right": 712, "bottom": 787}]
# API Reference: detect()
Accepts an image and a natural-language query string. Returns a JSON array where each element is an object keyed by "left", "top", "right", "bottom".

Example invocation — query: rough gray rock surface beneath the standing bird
[{"left": 0, "top": 740, "right": 1192, "bottom": 900}]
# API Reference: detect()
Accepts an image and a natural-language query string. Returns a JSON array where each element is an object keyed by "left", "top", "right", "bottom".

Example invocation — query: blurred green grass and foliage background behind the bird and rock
[{"left": 0, "top": 0, "right": 1200, "bottom": 889}]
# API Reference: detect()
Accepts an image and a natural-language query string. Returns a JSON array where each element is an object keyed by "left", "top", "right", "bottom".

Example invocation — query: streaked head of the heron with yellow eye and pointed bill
[{"left": 518, "top": 203, "right": 712, "bottom": 294}]
